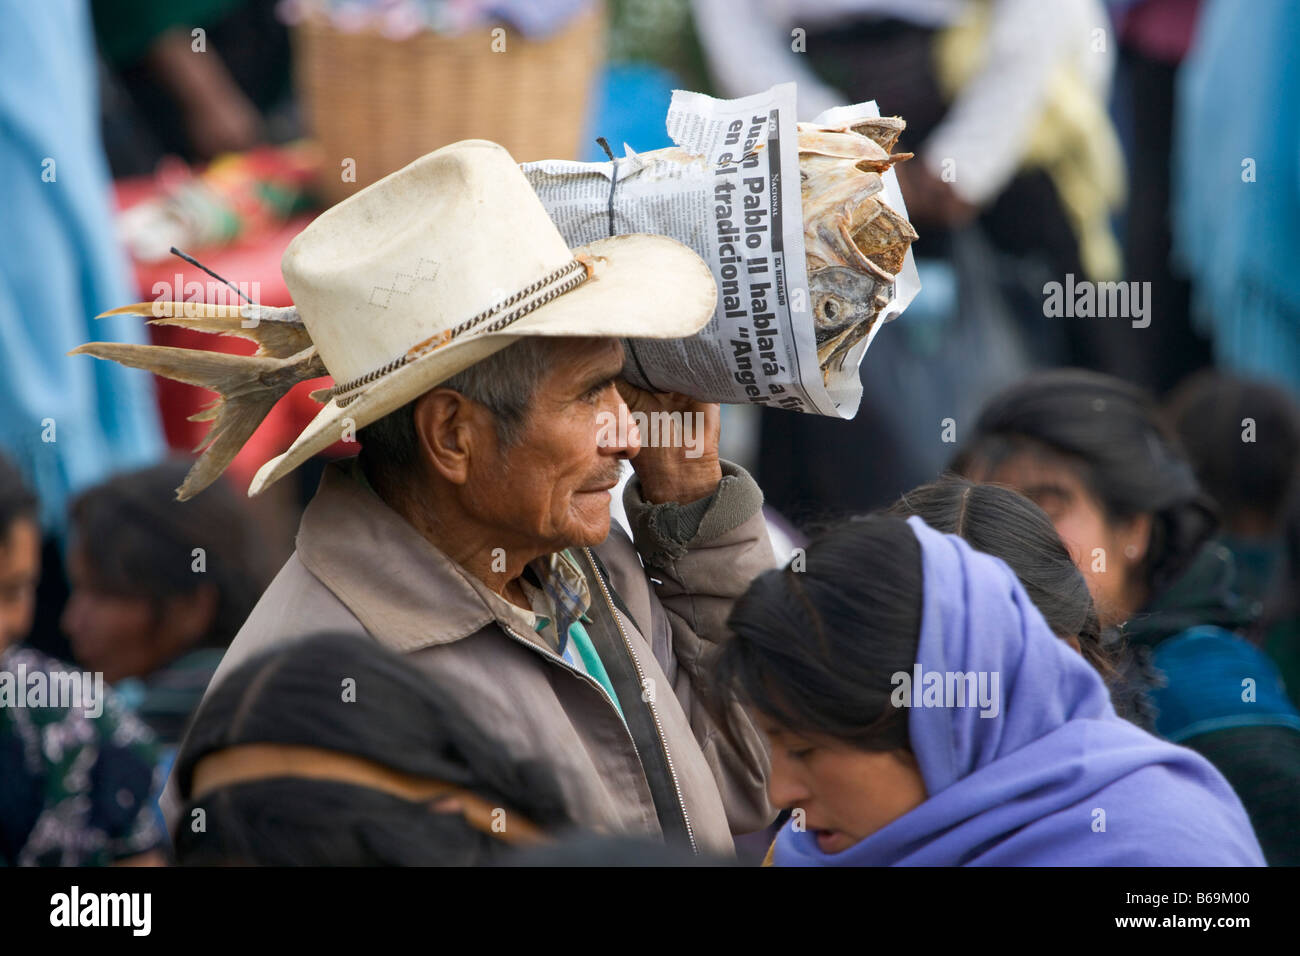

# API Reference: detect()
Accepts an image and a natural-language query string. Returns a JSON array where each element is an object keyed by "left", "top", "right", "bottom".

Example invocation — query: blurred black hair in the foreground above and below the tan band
[{"left": 174, "top": 633, "right": 569, "bottom": 866}]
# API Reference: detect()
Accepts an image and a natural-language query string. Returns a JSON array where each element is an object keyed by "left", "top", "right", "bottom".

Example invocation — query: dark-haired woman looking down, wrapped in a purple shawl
[{"left": 716, "top": 516, "right": 1264, "bottom": 866}]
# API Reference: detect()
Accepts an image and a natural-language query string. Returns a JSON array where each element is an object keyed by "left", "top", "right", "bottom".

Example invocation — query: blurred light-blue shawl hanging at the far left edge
[{"left": 0, "top": 0, "right": 164, "bottom": 657}]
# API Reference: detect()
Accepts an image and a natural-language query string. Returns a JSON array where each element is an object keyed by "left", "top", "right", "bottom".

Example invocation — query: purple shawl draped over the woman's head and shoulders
[{"left": 774, "top": 518, "right": 1264, "bottom": 866}]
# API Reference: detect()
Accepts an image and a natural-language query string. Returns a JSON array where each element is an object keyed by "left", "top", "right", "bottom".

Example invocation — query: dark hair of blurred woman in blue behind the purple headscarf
[{"left": 953, "top": 368, "right": 1217, "bottom": 597}]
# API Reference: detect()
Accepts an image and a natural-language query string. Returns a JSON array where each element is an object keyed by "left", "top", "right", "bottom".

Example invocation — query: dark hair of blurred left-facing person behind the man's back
[{"left": 70, "top": 459, "right": 265, "bottom": 648}]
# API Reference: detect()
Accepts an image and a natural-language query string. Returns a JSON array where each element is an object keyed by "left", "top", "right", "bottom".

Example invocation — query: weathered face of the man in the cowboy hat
[{"left": 467, "top": 338, "right": 641, "bottom": 553}]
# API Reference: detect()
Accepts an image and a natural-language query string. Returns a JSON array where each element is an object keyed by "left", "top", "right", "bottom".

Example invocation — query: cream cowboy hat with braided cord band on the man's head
[{"left": 241, "top": 139, "right": 718, "bottom": 496}]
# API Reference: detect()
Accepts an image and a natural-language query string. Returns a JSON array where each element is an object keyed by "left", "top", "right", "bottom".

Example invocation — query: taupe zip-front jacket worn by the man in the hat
[{"left": 170, "top": 463, "right": 775, "bottom": 852}]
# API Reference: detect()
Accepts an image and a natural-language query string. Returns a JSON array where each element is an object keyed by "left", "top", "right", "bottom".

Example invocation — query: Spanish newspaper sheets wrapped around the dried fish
[{"left": 523, "top": 83, "right": 920, "bottom": 419}]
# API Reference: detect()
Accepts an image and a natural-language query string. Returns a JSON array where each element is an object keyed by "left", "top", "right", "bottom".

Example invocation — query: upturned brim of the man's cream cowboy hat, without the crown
[{"left": 248, "top": 235, "right": 718, "bottom": 496}]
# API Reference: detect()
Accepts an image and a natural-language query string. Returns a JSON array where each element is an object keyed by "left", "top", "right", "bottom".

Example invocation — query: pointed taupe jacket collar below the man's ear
[{"left": 298, "top": 459, "right": 499, "bottom": 653}]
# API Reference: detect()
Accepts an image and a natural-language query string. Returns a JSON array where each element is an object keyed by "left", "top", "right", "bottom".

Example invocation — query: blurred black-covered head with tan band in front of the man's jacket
[{"left": 176, "top": 633, "right": 735, "bottom": 866}]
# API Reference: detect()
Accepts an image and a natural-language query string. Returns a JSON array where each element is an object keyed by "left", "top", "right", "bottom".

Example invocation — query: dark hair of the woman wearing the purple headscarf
[{"left": 712, "top": 515, "right": 922, "bottom": 750}]
